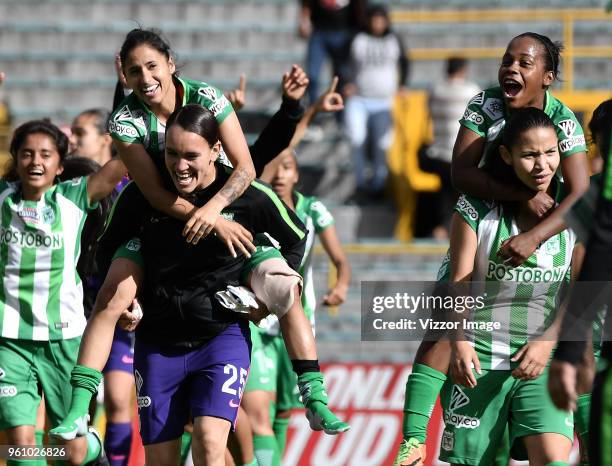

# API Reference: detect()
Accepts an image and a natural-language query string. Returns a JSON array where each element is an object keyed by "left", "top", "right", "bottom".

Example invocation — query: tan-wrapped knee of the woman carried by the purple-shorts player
[{"left": 249, "top": 258, "right": 302, "bottom": 319}]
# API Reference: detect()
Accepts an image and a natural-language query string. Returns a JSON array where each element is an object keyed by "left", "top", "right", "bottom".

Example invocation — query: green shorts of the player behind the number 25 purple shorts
[{"left": 245, "top": 324, "right": 304, "bottom": 411}]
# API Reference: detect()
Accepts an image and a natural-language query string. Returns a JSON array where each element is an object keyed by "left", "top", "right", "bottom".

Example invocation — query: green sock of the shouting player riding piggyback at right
[{"left": 403, "top": 364, "right": 446, "bottom": 443}]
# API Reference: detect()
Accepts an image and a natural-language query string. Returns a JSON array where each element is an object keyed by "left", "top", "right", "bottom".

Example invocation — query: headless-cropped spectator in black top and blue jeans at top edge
[{"left": 299, "top": 0, "right": 365, "bottom": 104}]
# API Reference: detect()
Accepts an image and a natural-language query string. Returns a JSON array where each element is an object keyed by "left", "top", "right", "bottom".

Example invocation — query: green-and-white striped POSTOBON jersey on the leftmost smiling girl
[{"left": 0, "top": 177, "right": 96, "bottom": 341}]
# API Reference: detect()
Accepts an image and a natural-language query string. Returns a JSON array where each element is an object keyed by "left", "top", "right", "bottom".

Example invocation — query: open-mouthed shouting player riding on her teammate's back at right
[{"left": 397, "top": 32, "right": 588, "bottom": 466}]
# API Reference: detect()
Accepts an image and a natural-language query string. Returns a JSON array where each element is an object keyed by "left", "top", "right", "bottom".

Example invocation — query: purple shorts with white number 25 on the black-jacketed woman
[{"left": 134, "top": 323, "right": 251, "bottom": 445}]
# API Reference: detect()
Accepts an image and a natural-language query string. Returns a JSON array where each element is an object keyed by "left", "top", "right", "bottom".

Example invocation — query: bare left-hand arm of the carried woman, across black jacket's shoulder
[{"left": 114, "top": 139, "right": 194, "bottom": 221}]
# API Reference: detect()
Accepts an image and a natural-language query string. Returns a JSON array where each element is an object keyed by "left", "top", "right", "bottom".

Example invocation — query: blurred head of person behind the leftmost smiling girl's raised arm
[{"left": 69, "top": 108, "right": 113, "bottom": 166}]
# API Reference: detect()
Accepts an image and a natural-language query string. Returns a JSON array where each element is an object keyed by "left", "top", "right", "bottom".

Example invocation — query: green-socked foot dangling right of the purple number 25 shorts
[{"left": 298, "top": 372, "right": 351, "bottom": 435}]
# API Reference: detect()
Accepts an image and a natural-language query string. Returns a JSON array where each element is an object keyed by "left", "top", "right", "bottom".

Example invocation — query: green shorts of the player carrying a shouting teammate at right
[{"left": 440, "top": 369, "right": 574, "bottom": 465}]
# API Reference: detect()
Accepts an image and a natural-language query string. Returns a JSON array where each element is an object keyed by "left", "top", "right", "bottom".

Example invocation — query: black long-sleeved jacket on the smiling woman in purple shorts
[{"left": 101, "top": 164, "right": 306, "bottom": 347}]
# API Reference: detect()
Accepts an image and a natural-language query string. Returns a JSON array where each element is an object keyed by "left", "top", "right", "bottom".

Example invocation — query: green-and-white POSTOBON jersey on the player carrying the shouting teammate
[{"left": 441, "top": 191, "right": 576, "bottom": 370}]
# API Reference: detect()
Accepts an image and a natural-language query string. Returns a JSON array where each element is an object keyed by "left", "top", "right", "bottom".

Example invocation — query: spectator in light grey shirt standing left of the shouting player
[{"left": 420, "top": 57, "right": 480, "bottom": 239}]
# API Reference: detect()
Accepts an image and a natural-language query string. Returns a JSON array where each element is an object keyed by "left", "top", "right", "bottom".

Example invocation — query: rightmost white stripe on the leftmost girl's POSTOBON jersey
[{"left": 57, "top": 194, "right": 87, "bottom": 339}]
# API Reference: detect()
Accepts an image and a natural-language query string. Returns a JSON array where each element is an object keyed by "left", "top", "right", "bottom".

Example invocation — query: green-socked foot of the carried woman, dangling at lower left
[{"left": 49, "top": 364, "right": 102, "bottom": 440}]
